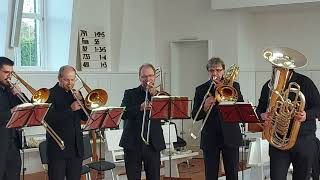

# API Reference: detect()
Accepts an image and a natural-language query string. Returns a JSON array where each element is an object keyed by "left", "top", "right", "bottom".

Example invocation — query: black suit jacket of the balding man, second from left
[{"left": 46, "top": 84, "right": 87, "bottom": 160}]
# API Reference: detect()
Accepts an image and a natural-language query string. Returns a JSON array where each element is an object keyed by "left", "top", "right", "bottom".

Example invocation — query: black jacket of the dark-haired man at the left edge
[{"left": 0, "top": 85, "right": 21, "bottom": 161}]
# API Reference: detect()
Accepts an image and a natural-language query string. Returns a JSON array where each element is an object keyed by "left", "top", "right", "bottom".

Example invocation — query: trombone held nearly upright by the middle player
[{"left": 140, "top": 67, "right": 170, "bottom": 144}]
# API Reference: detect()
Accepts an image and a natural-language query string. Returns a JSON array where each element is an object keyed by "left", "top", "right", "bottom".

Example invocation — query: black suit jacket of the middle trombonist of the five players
[{"left": 120, "top": 86, "right": 165, "bottom": 151}]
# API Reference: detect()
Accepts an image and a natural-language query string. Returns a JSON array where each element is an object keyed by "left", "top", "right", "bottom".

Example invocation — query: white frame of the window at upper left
[{"left": 14, "top": 0, "right": 47, "bottom": 71}]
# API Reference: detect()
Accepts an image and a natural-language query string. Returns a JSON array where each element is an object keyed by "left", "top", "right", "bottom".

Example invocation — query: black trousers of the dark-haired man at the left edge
[{"left": 0, "top": 143, "right": 21, "bottom": 180}]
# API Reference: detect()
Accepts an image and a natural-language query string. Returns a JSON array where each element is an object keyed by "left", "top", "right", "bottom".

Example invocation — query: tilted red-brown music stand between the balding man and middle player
[{"left": 83, "top": 107, "right": 125, "bottom": 172}]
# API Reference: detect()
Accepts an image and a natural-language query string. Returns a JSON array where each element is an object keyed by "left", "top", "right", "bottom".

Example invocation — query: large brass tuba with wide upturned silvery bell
[{"left": 263, "top": 47, "right": 307, "bottom": 150}]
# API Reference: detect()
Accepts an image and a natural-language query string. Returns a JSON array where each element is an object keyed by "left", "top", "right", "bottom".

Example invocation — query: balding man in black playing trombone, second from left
[{"left": 46, "top": 65, "right": 87, "bottom": 180}]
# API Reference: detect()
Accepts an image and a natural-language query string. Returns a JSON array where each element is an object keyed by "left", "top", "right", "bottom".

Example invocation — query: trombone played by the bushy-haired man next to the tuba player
[{"left": 190, "top": 64, "right": 239, "bottom": 139}]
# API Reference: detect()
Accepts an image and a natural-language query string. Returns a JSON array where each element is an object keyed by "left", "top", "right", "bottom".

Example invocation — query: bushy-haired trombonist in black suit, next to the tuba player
[{"left": 192, "top": 57, "right": 243, "bottom": 180}]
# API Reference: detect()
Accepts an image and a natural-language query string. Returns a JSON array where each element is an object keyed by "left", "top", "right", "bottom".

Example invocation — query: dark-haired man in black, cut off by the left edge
[{"left": 0, "top": 57, "right": 21, "bottom": 180}]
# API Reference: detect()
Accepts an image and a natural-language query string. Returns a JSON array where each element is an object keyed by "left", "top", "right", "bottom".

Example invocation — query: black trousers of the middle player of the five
[{"left": 124, "top": 143, "right": 160, "bottom": 180}]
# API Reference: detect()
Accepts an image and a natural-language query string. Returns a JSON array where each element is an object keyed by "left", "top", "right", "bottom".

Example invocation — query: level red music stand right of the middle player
[{"left": 149, "top": 96, "right": 190, "bottom": 178}]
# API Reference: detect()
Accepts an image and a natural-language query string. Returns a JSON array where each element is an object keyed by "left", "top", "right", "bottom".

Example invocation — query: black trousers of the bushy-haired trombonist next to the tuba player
[{"left": 203, "top": 146, "right": 239, "bottom": 180}]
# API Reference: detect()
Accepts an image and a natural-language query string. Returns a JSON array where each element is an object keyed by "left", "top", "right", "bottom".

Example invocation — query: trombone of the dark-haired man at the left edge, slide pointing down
[{"left": 7, "top": 71, "right": 65, "bottom": 150}]
